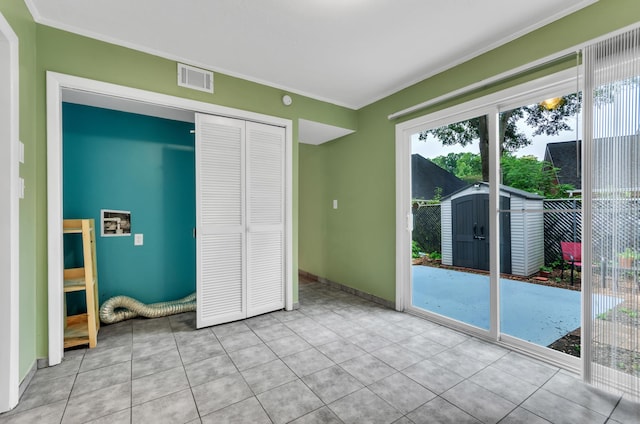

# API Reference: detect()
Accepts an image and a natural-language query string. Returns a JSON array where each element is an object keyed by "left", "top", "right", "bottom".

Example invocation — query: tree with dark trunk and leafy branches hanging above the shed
[{"left": 419, "top": 94, "right": 581, "bottom": 181}]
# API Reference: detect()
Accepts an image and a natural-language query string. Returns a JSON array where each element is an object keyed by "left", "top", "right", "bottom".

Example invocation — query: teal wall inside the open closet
[{"left": 62, "top": 103, "right": 196, "bottom": 314}]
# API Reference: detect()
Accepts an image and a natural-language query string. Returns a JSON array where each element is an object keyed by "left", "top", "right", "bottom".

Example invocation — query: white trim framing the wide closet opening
[{"left": 47, "top": 71, "right": 294, "bottom": 365}]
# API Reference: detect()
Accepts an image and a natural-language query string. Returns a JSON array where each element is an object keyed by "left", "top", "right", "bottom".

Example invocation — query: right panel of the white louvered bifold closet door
[{"left": 247, "top": 122, "right": 285, "bottom": 316}]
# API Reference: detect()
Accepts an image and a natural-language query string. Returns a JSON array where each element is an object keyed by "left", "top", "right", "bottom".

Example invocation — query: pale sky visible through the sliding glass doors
[{"left": 411, "top": 115, "right": 582, "bottom": 160}]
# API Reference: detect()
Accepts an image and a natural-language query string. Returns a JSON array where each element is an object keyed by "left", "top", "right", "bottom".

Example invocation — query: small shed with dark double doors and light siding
[{"left": 441, "top": 182, "right": 544, "bottom": 276}]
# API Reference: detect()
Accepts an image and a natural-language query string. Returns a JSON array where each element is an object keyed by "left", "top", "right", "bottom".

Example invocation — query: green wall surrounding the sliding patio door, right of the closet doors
[{"left": 299, "top": 0, "right": 640, "bottom": 301}]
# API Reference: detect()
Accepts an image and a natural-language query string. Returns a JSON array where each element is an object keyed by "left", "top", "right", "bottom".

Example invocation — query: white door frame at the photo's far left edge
[{"left": 0, "top": 13, "right": 20, "bottom": 412}]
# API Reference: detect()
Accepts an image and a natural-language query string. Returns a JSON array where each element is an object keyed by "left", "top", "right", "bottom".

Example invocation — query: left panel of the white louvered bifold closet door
[{"left": 196, "top": 114, "right": 246, "bottom": 328}]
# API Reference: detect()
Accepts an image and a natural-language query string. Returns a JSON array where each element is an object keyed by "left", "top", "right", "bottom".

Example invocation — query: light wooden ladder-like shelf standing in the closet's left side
[{"left": 62, "top": 219, "right": 100, "bottom": 348}]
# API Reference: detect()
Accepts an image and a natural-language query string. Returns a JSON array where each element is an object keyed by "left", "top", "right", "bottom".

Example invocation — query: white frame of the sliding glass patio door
[{"left": 395, "top": 68, "right": 581, "bottom": 372}]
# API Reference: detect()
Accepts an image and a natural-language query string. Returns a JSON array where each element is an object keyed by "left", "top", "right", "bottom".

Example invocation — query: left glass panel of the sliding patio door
[{"left": 411, "top": 116, "right": 490, "bottom": 330}]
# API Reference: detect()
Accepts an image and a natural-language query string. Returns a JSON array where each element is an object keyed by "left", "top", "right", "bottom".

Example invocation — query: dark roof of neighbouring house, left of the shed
[{"left": 411, "top": 153, "right": 467, "bottom": 200}]
